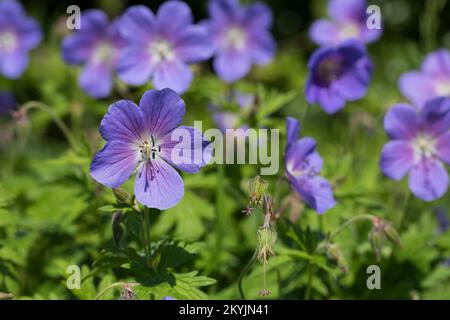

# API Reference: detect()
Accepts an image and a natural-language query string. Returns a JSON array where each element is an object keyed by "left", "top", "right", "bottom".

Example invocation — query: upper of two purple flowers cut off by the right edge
[{"left": 399, "top": 49, "right": 450, "bottom": 108}]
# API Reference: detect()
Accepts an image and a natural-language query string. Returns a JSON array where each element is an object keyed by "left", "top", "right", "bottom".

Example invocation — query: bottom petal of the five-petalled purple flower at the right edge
[{"left": 409, "top": 159, "right": 449, "bottom": 201}]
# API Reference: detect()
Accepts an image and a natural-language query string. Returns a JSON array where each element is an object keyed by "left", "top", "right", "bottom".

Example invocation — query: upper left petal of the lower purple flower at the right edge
[{"left": 384, "top": 104, "right": 419, "bottom": 140}]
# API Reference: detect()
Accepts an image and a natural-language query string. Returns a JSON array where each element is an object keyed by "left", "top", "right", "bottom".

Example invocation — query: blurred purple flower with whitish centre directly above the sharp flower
[{"left": 118, "top": 1, "right": 212, "bottom": 93}]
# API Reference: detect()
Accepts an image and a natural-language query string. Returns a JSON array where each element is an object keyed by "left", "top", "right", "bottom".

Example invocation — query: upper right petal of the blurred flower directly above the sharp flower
[{"left": 156, "top": 1, "right": 193, "bottom": 36}]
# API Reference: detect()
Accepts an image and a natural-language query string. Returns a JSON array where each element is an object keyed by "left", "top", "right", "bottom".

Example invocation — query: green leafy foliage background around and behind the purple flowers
[{"left": 0, "top": 0, "right": 450, "bottom": 299}]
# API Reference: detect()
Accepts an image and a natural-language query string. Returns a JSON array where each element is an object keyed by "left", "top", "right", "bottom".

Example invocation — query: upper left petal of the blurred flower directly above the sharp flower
[{"left": 119, "top": 5, "right": 156, "bottom": 44}]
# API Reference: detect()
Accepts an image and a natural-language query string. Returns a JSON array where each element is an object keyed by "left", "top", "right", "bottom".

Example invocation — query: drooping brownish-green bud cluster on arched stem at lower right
[{"left": 369, "top": 217, "right": 401, "bottom": 260}]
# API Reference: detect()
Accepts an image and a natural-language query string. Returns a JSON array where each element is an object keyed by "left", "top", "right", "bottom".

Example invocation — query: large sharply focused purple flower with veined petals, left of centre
[{"left": 91, "top": 89, "right": 211, "bottom": 210}]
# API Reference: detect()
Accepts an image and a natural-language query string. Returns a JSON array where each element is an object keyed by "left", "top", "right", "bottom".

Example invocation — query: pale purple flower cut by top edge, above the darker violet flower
[{"left": 310, "top": 0, "right": 382, "bottom": 46}]
